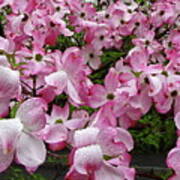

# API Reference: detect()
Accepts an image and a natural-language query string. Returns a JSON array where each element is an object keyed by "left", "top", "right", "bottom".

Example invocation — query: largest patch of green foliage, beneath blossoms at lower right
[{"left": 130, "top": 109, "right": 176, "bottom": 153}]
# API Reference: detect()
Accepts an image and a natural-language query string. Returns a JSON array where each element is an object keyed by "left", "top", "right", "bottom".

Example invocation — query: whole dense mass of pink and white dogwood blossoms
[{"left": 0, "top": 0, "right": 180, "bottom": 180}]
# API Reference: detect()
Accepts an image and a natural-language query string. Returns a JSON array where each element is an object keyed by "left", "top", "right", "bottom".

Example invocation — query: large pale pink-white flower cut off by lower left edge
[{"left": 0, "top": 98, "right": 47, "bottom": 172}]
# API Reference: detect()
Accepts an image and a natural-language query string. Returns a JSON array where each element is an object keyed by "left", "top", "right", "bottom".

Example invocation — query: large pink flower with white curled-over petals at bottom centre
[{"left": 66, "top": 128, "right": 133, "bottom": 180}]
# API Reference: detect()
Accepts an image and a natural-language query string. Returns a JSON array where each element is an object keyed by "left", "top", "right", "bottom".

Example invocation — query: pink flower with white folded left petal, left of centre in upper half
[{"left": 45, "top": 47, "right": 83, "bottom": 104}]
